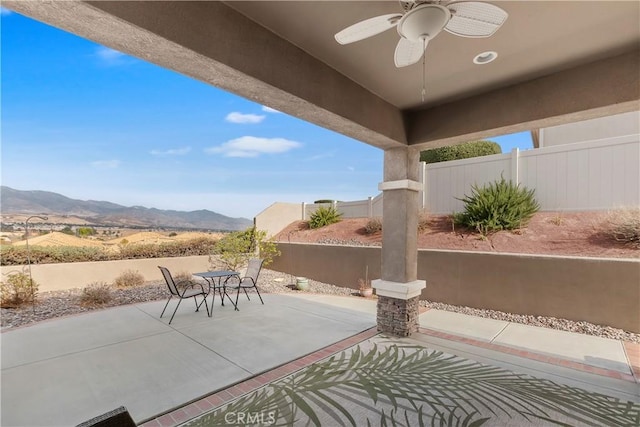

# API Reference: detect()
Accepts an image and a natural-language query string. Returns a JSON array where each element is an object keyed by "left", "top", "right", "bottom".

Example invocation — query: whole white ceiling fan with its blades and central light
[{"left": 335, "top": 0, "right": 508, "bottom": 68}]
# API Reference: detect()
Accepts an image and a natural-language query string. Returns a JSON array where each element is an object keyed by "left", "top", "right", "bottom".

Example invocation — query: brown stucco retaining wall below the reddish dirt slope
[{"left": 269, "top": 243, "right": 640, "bottom": 333}]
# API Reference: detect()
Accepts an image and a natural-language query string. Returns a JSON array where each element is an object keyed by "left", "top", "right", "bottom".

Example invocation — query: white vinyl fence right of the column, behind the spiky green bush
[{"left": 424, "top": 135, "right": 640, "bottom": 214}]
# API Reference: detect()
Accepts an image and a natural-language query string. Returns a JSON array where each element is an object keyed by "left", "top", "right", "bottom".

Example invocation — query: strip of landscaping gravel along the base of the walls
[{"left": 1, "top": 269, "right": 640, "bottom": 343}]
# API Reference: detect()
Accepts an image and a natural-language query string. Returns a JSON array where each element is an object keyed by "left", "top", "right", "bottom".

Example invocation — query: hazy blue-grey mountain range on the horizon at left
[{"left": 0, "top": 186, "right": 253, "bottom": 230}]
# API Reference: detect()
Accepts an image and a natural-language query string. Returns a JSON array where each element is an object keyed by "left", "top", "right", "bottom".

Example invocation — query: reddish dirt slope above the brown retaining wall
[{"left": 276, "top": 212, "right": 640, "bottom": 258}]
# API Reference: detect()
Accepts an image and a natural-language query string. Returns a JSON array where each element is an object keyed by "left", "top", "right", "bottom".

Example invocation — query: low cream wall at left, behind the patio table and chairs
[{"left": 0, "top": 255, "right": 209, "bottom": 292}]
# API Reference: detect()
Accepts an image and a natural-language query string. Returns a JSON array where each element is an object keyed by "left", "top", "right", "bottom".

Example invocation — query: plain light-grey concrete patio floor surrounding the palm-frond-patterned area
[{"left": 0, "top": 295, "right": 640, "bottom": 426}]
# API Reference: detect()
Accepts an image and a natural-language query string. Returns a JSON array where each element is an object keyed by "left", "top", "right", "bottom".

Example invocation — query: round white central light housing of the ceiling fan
[{"left": 398, "top": 4, "right": 451, "bottom": 41}]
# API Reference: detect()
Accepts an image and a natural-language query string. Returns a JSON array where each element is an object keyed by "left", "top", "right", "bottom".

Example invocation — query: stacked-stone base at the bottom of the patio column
[{"left": 377, "top": 296, "right": 420, "bottom": 337}]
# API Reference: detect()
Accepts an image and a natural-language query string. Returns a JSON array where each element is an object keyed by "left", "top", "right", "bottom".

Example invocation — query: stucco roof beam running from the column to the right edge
[{"left": 406, "top": 50, "right": 640, "bottom": 149}]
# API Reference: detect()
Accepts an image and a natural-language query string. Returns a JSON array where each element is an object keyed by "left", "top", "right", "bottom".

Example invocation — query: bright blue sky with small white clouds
[{"left": 0, "top": 9, "right": 531, "bottom": 218}]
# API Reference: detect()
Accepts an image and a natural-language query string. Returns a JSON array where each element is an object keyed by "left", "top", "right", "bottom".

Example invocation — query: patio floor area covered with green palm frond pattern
[{"left": 187, "top": 345, "right": 640, "bottom": 427}]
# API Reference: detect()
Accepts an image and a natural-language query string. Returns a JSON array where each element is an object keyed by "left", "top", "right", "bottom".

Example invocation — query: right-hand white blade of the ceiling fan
[{"left": 444, "top": 1, "right": 509, "bottom": 37}]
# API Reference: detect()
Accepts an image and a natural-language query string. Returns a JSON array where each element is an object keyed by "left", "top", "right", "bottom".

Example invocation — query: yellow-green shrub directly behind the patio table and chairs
[{"left": 211, "top": 227, "right": 280, "bottom": 271}]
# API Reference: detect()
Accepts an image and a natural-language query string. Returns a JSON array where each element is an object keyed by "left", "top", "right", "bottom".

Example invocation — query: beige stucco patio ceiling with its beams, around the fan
[{"left": 3, "top": 1, "right": 640, "bottom": 149}]
